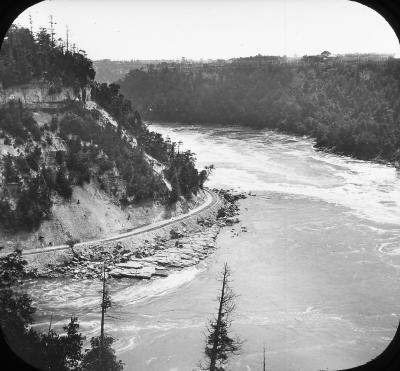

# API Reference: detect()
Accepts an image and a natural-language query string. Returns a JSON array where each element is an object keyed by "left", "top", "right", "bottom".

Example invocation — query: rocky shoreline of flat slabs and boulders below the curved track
[{"left": 28, "top": 189, "right": 246, "bottom": 279}]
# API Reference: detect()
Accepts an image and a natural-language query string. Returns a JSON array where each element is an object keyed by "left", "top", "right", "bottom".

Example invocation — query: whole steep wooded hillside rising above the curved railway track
[{"left": 0, "top": 26, "right": 212, "bottom": 249}]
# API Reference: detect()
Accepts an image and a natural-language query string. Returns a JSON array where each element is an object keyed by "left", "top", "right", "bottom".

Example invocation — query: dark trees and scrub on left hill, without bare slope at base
[{"left": 0, "top": 26, "right": 208, "bottom": 232}]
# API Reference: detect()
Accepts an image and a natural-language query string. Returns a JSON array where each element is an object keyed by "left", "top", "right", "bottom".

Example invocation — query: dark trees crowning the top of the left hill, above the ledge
[{"left": 0, "top": 25, "right": 95, "bottom": 92}]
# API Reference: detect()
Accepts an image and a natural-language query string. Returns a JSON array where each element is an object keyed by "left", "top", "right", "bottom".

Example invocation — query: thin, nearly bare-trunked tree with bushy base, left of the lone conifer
[{"left": 81, "top": 265, "right": 124, "bottom": 371}]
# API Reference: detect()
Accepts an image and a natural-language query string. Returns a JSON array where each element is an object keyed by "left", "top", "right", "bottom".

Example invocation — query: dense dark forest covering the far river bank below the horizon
[{"left": 119, "top": 57, "right": 400, "bottom": 161}]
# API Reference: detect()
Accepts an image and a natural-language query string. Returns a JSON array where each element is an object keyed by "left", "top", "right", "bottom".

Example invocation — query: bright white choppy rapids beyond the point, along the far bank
[{"left": 154, "top": 125, "right": 400, "bottom": 225}]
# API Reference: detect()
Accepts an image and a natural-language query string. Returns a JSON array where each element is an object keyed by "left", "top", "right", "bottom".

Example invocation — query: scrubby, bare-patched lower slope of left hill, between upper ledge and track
[{"left": 0, "top": 102, "right": 203, "bottom": 253}]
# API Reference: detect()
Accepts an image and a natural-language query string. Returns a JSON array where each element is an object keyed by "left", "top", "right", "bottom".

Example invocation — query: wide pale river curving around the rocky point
[{"left": 23, "top": 124, "right": 400, "bottom": 371}]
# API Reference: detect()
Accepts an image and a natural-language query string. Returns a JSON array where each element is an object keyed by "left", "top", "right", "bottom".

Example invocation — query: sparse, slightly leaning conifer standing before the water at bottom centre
[{"left": 201, "top": 263, "right": 242, "bottom": 371}]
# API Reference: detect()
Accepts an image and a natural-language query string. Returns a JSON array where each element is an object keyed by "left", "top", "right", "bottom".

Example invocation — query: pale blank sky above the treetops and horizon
[{"left": 14, "top": 0, "right": 400, "bottom": 60}]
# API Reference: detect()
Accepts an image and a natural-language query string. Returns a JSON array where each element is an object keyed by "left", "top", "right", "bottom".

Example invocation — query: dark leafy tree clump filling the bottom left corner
[{"left": 0, "top": 250, "right": 84, "bottom": 371}]
